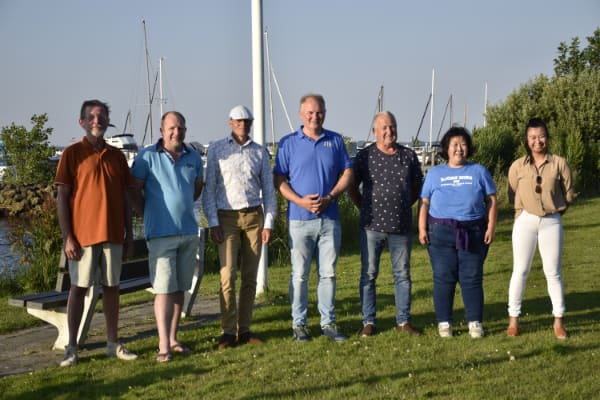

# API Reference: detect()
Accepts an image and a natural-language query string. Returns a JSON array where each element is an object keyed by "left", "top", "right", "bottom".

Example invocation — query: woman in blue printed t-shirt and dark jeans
[{"left": 419, "top": 127, "right": 498, "bottom": 338}]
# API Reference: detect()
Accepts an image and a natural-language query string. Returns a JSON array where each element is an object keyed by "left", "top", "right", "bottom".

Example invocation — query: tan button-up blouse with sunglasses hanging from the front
[{"left": 508, "top": 153, "right": 575, "bottom": 218}]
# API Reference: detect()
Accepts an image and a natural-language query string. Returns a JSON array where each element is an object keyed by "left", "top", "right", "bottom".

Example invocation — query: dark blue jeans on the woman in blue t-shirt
[{"left": 428, "top": 224, "right": 488, "bottom": 323}]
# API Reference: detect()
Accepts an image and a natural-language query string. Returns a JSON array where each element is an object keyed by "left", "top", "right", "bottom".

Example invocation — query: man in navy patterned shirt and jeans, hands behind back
[{"left": 349, "top": 111, "right": 423, "bottom": 336}]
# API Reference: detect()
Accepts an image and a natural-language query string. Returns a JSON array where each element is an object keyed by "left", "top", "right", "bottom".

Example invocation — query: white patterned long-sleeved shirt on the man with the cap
[{"left": 202, "top": 135, "right": 277, "bottom": 229}]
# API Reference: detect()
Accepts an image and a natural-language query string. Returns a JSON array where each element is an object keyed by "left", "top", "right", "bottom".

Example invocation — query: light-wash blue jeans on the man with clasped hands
[{"left": 289, "top": 218, "right": 342, "bottom": 327}]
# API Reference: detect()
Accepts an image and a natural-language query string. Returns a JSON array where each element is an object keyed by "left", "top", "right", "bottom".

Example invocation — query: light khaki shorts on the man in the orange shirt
[{"left": 69, "top": 242, "right": 123, "bottom": 287}]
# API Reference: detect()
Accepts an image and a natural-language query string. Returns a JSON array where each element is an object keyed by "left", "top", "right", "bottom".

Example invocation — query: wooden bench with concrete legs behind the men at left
[{"left": 8, "top": 228, "right": 207, "bottom": 350}]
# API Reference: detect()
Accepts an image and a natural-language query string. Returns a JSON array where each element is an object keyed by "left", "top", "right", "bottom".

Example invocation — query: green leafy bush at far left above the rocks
[{"left": 0, "top": 114, "right": 55, "bottom": 184}]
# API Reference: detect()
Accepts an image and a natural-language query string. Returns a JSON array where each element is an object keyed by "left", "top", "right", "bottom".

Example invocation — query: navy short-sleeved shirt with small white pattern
[{"left": 354, "top": 144, "right": 423, "bottom": 234}]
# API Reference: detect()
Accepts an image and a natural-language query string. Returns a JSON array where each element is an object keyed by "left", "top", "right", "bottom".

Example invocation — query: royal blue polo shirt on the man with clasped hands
[{"left": 273, "top": 126, "right": 352, "bottom": 221}]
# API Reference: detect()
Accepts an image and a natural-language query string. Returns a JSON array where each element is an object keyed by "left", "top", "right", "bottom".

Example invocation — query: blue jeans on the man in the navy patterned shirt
[{"left": 359, "top": 229, "right": 411, "bottom": 325}]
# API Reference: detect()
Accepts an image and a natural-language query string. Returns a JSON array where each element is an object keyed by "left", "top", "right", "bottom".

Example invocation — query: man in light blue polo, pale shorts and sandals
[{"left": 131, "top": 111, "right": 203, "bottom": 362}]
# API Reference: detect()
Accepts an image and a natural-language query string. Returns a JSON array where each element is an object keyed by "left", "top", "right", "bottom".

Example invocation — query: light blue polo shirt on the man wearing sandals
[{"left": 131, "top": 139, "right": 203, "bottom": 239}]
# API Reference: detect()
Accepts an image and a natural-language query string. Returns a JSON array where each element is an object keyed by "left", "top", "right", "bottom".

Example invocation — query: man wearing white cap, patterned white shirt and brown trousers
[{"left": 202, "top": 105, "right": 277, "bottom": 350}]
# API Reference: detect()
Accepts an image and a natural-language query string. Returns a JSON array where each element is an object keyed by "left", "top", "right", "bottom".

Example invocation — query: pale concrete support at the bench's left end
[{"left": 27, "top": 286, "right": 100, "bottom": 350}]
